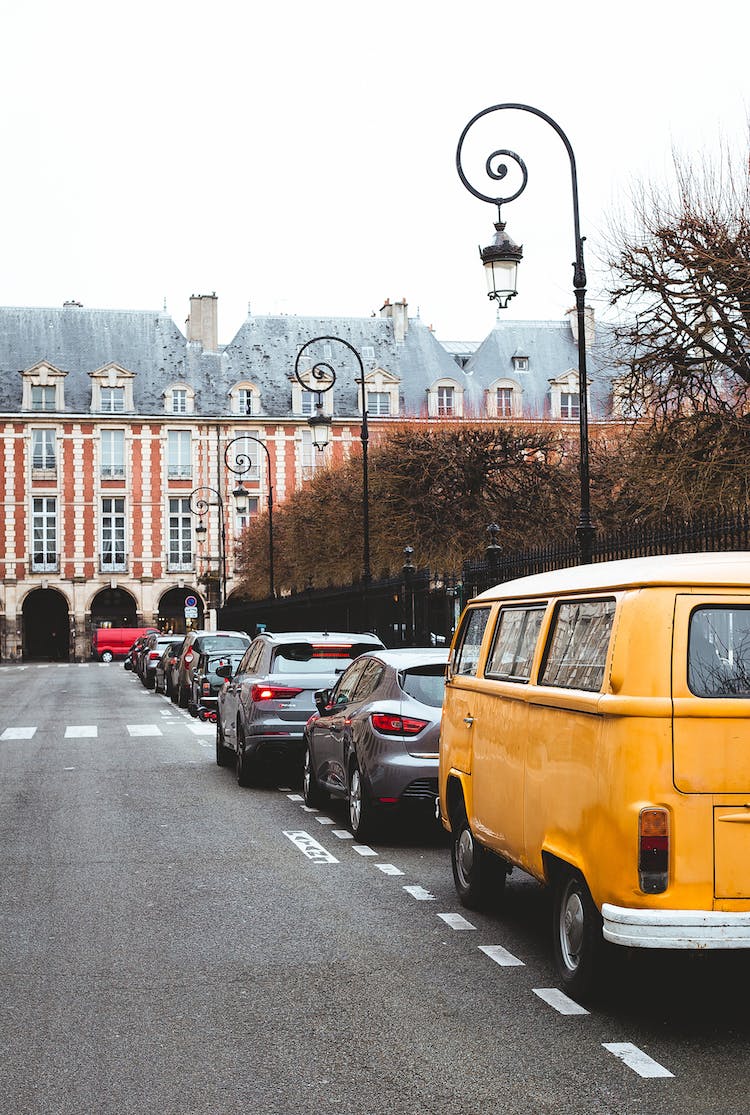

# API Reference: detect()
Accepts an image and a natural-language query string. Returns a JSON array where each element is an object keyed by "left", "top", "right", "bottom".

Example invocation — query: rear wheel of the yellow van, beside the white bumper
[{"left": 552, "top": 870, "right": 604, "bottom": 998}]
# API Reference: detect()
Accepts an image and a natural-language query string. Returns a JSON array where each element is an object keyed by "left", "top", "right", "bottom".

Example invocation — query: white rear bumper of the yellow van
[{"left": 602, "top": 902, "right": 750, "bottom": 949}]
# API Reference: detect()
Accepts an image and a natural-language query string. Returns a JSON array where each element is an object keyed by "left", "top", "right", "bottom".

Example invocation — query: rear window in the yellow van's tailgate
[{"left": 688, "top": 607, "right": 750, "bottom": 697}]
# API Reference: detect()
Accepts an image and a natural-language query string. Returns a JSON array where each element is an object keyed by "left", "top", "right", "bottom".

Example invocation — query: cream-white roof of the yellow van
[{"left": 475, "top": 550, "right": 750, "bottom": 600}]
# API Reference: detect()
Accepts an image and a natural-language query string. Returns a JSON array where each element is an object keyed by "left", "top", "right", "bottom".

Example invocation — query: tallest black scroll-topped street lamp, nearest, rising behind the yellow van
[{"left": 456, "top": 104, "right": 595, "bottom": 565}]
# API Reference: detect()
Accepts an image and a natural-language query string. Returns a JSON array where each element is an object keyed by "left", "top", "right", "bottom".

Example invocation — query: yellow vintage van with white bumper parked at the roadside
[{"left": 439, "top": 553, "right": 750, "bottom": 996}]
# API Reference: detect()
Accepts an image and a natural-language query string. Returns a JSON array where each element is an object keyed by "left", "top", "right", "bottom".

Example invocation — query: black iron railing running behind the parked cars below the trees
[{"left": 221, "top": 508, "right": 750, "bottom": 647}]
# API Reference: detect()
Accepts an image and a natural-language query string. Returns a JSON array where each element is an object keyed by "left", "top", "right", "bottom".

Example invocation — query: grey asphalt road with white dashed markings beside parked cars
[{"left": 0, "top": 663, "right": 750, "bottom": 1115}]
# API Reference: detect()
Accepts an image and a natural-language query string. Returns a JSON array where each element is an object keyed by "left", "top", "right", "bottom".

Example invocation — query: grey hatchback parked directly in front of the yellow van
[{"left": 303, "top": 647, "right": 448, "bottom": 840}]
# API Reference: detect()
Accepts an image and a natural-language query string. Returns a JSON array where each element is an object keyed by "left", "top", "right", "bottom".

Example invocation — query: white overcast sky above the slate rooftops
[{"left": 0, "top": 0, "right": 750, "bottom": 342}]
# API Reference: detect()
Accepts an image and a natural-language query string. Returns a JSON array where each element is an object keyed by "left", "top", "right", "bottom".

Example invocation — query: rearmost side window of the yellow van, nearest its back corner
[{"left": 539, "top": 600, "right": 615, "bottom": 692}]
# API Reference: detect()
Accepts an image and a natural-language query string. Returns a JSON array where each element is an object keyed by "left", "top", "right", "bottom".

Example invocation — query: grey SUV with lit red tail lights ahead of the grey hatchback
[{"left": 216, "top": 631, "right": 382, "bottom": 786}]
